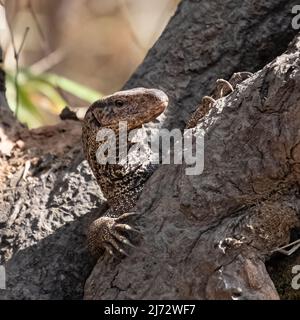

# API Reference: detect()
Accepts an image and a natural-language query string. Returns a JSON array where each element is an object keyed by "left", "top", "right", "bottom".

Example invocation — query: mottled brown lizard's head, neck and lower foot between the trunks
[{"left": 82, "top": 88, "right": 168, "bottom": 257}]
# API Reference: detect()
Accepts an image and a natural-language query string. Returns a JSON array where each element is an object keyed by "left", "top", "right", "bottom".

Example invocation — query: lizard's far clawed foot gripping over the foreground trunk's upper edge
[{"left": 186, "top": 72, "right": 252, "bottom": 129}]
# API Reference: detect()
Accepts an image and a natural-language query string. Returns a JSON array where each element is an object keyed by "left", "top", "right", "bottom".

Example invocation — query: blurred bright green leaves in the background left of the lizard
[{"left": 6, "top": 68, "right": 102, "bottom": 128}]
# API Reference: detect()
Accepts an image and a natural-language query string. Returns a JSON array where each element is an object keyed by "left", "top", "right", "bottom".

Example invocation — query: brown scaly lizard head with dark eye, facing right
[{"left": 84, "top": 88, "right": 168, "bottom": 130}]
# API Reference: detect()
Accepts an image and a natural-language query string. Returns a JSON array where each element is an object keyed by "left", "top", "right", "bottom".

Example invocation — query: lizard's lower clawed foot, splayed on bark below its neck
[{"left": 88, "top": 212, "right": 140, "bottom": 257}]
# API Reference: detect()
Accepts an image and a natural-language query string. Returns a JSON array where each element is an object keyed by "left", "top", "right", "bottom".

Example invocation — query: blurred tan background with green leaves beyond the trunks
[{"left": 0, "top": 0, "right": 180, "bottom": 128}]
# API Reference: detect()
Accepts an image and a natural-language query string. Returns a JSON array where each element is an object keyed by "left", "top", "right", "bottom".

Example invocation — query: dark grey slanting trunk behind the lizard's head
[{"left": 126, "top": 0, "right": 297, "bottom": 128}]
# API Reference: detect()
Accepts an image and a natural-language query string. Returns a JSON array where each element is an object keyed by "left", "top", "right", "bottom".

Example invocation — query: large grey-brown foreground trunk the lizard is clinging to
[{"left": 85, "top": 36, "right": 300, "bottom": 299}]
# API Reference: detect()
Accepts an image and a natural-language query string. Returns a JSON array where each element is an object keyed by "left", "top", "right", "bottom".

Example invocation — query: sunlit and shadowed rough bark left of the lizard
[{"left": 0, "top": 48, "right": 101, "bottom": 299}]
